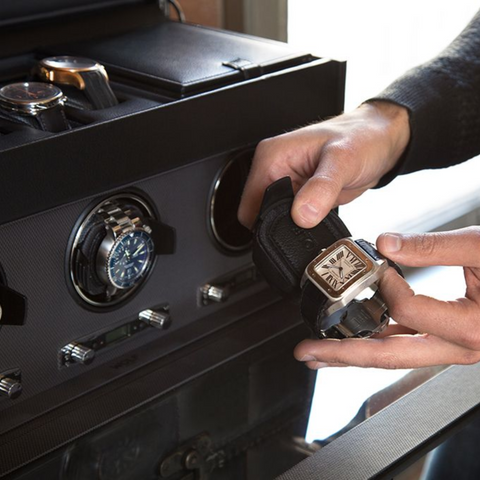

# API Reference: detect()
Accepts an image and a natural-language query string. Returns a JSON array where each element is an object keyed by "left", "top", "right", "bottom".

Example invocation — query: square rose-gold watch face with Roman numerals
[{"left": 307, "top": 239, "right": 374, "bottom": 298}]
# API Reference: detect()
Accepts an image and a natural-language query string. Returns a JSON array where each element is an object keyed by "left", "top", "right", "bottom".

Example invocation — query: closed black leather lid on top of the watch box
[{"left": 58, "top": 21, "right": 311, "bottom": 96}]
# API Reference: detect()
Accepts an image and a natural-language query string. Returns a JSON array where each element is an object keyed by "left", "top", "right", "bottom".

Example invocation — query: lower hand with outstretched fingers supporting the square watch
[{"left": 294, "top": 227, "right": 480, "bottom": 369}]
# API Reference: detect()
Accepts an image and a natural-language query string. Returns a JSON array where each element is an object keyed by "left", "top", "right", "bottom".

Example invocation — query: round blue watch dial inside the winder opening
[{"left": 107, "top": 230, "right": 153, "bottom": 289}]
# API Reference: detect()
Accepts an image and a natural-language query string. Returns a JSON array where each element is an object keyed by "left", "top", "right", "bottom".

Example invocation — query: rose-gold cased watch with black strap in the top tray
[{"left": 35, "top": 55, "right": 118, "bottom": 110}]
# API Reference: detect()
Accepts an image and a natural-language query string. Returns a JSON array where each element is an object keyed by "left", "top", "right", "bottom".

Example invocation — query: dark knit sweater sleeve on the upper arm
[{"left": 369, "top": 11, "right": 480, "bottom": 186}]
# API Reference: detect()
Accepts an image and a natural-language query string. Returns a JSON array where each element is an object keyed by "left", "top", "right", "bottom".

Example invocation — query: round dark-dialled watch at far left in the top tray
[{"left": 0, "top": 82, "right": 70, "bottom": 132}]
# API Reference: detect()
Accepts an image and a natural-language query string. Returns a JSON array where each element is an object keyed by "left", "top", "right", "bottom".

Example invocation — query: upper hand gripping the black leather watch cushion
[{"left": 238, "top": 102, "right": 410, "bottom": 228}]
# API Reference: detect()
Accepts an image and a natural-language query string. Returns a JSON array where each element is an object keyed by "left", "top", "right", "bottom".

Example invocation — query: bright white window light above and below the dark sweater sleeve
[{"left": 288, "top": 0, "right": 480, "bottom": 240}]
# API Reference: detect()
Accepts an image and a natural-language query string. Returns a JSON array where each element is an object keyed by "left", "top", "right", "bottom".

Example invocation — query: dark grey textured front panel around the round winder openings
[{"left": 0, "top": 149, "right": 258, "bottom": 424}]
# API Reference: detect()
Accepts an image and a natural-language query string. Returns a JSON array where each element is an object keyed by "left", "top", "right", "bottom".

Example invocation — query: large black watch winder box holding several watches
[{"left": 0, "top": 0, "right": 345, "bottom": 480}]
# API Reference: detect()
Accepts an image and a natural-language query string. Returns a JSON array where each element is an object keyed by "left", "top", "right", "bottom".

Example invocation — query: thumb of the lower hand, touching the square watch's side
[{"left": 377, "top": 227, "right": 480, "bottom": 267}]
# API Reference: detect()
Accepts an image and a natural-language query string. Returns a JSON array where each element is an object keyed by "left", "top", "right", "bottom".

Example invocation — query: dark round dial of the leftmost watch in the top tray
[{"left": 0, "top": 82, "right": 63, "bottom": 106}]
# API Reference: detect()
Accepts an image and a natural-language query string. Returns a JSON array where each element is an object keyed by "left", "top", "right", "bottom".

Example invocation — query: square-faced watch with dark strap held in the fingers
[{"left": 301, "top": 238, "right": 398, "bottom": 338}]
